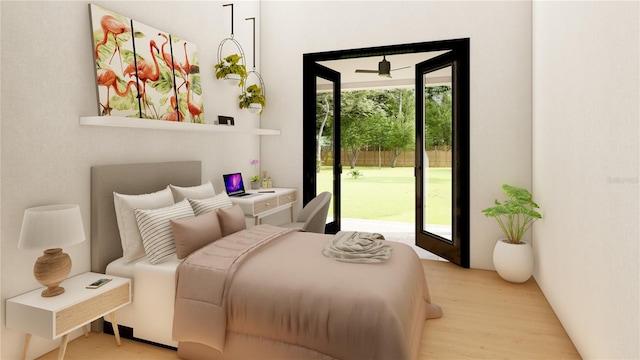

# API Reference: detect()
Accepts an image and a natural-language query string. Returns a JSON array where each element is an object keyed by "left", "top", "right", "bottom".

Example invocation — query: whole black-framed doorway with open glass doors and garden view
[{"left": 302, "top": 38, "right": 470, "bottom": 267}]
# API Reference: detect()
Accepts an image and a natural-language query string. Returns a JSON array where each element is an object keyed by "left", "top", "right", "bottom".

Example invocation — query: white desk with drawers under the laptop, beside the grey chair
[{"left": 229, "top": 188, "right": 298, "bottom": 225}]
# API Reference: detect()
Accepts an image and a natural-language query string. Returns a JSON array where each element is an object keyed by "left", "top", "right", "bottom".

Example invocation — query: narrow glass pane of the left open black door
[{"left": 316, "top": 77, "right": 335, "bottom": 223}]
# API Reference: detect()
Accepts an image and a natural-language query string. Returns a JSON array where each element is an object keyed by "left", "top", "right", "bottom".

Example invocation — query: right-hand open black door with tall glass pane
[{"left": 416, "top": 49, "right": 469, "bottom": 267}]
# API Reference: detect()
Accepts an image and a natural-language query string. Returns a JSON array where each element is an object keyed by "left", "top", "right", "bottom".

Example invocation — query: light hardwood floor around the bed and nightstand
[{"left": 39, "top": 260, "right": 580, "bottom": 360}]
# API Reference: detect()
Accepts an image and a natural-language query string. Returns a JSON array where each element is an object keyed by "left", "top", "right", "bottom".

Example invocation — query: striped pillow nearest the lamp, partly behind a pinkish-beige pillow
[{"left": 136, "top": 200, "right": 195, "bottom": 264}]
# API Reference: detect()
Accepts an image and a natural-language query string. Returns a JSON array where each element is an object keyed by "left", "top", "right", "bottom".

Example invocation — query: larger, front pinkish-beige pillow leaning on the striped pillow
[{"left": 170, "top": 211, "right": 222, "bottom": 259}]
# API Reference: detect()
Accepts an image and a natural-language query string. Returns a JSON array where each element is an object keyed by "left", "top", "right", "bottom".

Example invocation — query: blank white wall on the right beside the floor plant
[{"left": 533, "top": 1, "right": 640, "bottom": 359}]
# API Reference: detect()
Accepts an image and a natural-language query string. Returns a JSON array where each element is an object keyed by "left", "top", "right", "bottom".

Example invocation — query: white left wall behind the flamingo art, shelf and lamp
[{"left": 0, "top": 1, "right": 260, "bottom": 359}]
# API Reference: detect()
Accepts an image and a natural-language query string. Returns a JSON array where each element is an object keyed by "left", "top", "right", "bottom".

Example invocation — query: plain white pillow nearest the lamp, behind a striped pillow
[{"left": 113, "top": 186, "right": 174, "bottom": 263}]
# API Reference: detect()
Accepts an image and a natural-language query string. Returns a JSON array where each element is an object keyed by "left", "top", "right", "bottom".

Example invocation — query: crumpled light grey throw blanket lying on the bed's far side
[{"left": 322, "top": 231, "right": 392, "bottom": 263}]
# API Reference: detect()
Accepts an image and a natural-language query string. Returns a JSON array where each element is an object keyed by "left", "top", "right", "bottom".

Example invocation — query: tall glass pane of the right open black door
[{"left": 422, "top": 66, "right": 453, "bottom": 241}]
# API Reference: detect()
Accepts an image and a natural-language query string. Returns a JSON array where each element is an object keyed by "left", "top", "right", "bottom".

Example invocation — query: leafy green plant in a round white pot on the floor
[{"left": 482, "top": 184, "right": 542, "bottom": 283}]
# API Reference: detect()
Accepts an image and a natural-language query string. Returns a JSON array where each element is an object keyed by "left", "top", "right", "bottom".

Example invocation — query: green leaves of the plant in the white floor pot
[{"left": 482, "top": 184, "right": 542, "bottom": 244}]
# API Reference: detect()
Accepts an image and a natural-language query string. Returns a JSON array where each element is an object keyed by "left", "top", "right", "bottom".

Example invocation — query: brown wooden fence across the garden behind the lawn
[{"left": 322, "top": 149, "right": 452, "bottom": 167}]
